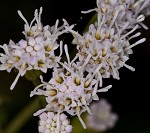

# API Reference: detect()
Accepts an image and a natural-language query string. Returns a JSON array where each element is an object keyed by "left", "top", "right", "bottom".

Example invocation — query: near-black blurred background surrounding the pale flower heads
[{"left": 0, "top": 0, "right": 150, "bottom": 133}]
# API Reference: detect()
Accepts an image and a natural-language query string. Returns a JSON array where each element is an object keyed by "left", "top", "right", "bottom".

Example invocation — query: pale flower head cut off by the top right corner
[{"left": 82, "top": 0, "right": 150, "bottom": 29}]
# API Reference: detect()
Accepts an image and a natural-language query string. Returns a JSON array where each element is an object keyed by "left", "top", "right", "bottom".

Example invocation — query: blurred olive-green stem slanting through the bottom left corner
[{"left": 2, "top": 97, "right": 41, "bottom": 133}]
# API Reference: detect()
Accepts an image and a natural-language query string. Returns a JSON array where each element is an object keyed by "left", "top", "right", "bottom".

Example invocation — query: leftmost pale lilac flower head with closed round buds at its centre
[{"left": 0, "top": 8, "right": 73, "bottom": 90}]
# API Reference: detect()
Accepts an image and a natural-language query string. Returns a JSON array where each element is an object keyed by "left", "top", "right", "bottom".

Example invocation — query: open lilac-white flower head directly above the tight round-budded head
[{"left": 30, "top": 45, "right": 111, "bottom": 128}]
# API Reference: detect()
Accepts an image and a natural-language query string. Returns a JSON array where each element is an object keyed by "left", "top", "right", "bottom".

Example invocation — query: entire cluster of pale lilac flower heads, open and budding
[{"left": 0, "top": 0, "right": 150, "bottom": 133}]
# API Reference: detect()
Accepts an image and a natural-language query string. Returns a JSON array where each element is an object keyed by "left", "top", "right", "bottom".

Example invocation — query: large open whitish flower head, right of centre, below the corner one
[{"left": 66, "top": 9, "right": 146, "bottom": 84}]
